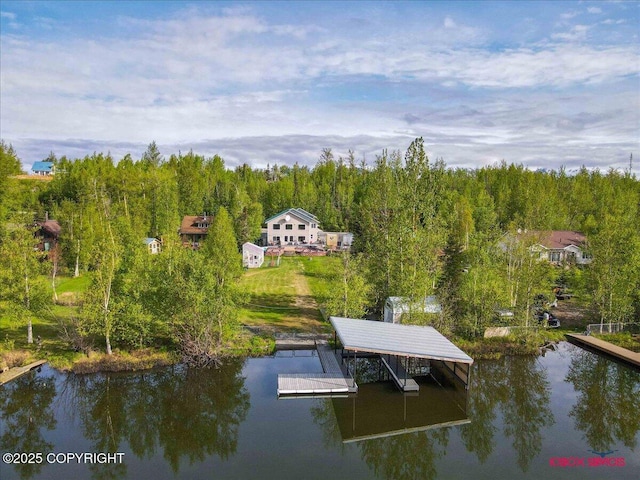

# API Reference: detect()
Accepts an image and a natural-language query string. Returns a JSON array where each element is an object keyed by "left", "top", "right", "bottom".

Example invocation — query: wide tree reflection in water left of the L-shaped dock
[{"left": 62, "top": 360, "right": 249, "bottom": 478}]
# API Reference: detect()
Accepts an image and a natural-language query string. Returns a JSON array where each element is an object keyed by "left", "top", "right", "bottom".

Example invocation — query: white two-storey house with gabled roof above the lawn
[{"left": 264, "top": 208, "right": 319, "bottom": 245}]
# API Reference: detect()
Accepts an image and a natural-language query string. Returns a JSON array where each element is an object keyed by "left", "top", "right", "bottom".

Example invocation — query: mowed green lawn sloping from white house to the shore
[{"left": 239, "top": 257, "right": 338, "bottom": 332}]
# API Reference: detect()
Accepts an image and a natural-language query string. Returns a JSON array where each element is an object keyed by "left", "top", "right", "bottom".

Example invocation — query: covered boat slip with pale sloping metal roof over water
[{"left": 329, "top": 317, "right": 473, "bottom": 391}]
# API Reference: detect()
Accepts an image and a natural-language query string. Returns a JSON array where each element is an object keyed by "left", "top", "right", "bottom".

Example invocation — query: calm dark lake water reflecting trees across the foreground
[{"left": 0, "top": 343, "right": 640, "bottom": 480}]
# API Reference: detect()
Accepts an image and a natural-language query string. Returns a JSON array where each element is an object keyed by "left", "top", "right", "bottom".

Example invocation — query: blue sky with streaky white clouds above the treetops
[{"left": 0, "top": 0, "right": 640, "bottom": 173}]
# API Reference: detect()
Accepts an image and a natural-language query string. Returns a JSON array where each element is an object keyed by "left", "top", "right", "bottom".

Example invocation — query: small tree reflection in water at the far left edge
[{"left": 0, "top": 372, "right": 56, "bottom": 478}]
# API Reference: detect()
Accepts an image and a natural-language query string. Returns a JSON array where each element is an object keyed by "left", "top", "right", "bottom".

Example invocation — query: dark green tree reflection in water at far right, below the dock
[{"left": 566, "top": 349, "right": 640, "bottom": 452}]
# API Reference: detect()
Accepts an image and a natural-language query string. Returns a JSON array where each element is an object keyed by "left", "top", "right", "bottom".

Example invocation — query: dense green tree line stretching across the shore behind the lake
[{"left": 0, "top": 139, "right": 640, "bottom": 353}]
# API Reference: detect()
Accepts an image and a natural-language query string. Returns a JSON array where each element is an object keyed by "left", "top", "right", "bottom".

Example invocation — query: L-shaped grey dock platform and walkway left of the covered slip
[{"left": 278, "top": 343, "right": 358, "bottom": 396}]
